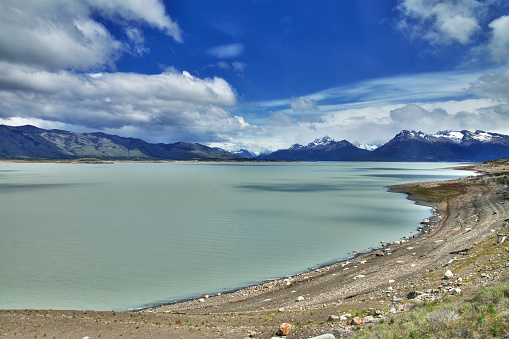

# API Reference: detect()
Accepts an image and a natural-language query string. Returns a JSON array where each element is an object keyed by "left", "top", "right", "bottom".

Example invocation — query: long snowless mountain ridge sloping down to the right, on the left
[{"left": 0, "top": 125, "right": 241, "bottom": 160}]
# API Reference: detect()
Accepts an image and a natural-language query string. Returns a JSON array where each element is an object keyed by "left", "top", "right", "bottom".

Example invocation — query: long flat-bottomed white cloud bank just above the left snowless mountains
[{"left": 0, "top": 62, "right": 251, "bottom": 141}]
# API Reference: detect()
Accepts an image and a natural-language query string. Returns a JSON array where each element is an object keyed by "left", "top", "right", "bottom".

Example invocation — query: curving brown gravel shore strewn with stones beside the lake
[{"left": 0, "top": 164, "right": 509, "bottom": 338}]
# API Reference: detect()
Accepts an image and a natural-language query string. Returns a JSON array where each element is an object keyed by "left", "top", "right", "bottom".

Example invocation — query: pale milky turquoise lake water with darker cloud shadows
[{"left": 0, "top": 162, "right": 471, "bottom": 310}]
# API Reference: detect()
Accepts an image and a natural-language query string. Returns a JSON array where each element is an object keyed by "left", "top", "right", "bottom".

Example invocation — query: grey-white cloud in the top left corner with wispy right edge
[{"left": 0, "top": 0, "right": 182, "bottom": 71}]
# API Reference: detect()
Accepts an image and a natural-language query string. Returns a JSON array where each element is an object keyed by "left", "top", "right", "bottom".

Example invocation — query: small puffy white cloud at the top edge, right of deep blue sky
[{"left": 398, "top": 0, "right": 497, "bottom": 45}]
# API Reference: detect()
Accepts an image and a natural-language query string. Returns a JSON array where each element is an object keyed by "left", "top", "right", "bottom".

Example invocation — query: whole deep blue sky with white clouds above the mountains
[{"left": 0, "top": 0, "right": 509, "bottom": 153}]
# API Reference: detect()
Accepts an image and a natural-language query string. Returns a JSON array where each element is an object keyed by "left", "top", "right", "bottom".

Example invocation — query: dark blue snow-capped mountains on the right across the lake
[{"left": 258, "top": 130, "right": 509, "bottom": 162}]
